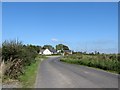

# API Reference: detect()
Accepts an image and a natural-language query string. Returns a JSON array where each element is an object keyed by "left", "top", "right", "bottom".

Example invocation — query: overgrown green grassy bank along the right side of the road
[{"left": 61, "top": 54, "right": 120, "bottom": 73}]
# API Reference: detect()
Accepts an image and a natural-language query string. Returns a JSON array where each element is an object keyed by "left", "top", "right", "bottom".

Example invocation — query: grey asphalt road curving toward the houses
[{"left": 35, "top": 56, "right": 118, "bottom": 88}]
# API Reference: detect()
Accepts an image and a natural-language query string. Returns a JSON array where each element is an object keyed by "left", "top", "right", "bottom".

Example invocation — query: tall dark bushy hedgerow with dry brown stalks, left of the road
[{"left": 2, "top": 40, "right": 38, "bottom": 79}]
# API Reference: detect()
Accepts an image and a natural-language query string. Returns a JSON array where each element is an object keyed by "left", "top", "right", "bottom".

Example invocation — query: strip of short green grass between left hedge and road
[{"left": 19, "top": 56, "right": 43, "bottom": 88}]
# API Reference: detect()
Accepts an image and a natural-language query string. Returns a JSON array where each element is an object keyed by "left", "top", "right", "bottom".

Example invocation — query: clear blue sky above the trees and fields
[{"left": 2, "top": 2, "right": 118, "bottom": 53}]
